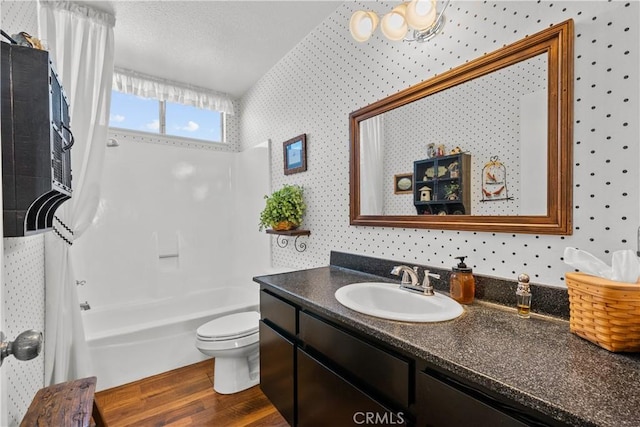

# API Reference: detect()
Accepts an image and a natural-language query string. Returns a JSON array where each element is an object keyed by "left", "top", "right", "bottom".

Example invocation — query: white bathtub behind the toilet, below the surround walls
[{"left": 82, "top": 279, "right": 259, "bottom": 390}]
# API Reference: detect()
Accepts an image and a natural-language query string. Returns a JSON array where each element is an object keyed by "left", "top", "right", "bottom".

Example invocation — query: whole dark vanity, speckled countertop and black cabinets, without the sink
[{"left": 254, "top": 253, "right": 640, "bottom": 427}]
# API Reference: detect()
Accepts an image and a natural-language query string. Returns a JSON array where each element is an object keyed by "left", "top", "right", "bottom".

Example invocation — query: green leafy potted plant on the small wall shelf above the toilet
[{"left": 260, "top": 185, "right": 307, "bottom": 231}]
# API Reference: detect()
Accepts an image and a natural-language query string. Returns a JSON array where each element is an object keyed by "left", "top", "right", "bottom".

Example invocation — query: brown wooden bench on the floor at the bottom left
[{"left": 20, "top": 377, "right": 106, "bottom": 427}]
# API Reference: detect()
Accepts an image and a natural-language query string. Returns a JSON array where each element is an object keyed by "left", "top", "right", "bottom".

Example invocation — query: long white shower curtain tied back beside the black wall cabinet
[{"left": 38, "top": 1, "right": 115, "bottom": 384}]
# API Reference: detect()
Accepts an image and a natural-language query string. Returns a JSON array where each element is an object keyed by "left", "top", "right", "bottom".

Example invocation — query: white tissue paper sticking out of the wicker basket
[{"left": 564, "top": 247, "right": 640, "bottom": 283}]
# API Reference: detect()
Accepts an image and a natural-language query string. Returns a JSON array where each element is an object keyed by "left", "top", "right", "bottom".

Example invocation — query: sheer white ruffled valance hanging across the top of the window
[{"left": 113, "top": 68, "right": 233, "bottom": 114}]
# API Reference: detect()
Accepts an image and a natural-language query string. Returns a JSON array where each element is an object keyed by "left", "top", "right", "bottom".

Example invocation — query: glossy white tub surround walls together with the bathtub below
[{"left": 73, "top": 141, "right": 276, "bottom": 390}]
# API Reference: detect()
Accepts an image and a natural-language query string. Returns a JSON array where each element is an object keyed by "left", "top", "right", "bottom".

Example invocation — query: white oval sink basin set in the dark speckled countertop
[{"left": 335, "top": 282, "right": 464, "bottom": 322}]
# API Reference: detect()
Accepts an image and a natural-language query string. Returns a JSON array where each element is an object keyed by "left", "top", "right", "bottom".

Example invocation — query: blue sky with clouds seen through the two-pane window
[{"left": 109, "top": 91, "right": 222, "bottom": 142}]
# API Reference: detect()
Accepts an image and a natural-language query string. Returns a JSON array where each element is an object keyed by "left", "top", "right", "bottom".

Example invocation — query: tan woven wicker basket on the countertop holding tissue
[{"left": 565, "top": 273, "right": 640, "bottom": 352}]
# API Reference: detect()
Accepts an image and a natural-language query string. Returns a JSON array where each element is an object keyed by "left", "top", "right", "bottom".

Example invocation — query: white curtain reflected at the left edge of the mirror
[{"left": 360, "top": 115, "right": 384, "bottom": 215}]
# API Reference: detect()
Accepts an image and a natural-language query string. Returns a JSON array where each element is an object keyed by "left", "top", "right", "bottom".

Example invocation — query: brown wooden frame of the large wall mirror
[{"left": 349, "top": 20, "right": 574, "bottom": 235}]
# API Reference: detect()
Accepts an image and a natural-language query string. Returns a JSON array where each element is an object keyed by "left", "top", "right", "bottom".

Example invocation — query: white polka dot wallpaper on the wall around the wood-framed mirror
[{"left": 241, "top": 0, "right": 640, "bottom": 287}]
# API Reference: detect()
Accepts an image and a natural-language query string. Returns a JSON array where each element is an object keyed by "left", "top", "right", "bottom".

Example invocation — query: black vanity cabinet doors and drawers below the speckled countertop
[{"left": 260, "top": 288, "right": 563, "bottom": 427}]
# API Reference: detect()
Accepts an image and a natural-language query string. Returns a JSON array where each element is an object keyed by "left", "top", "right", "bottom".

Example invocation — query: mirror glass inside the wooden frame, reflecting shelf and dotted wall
[{"left": 360, "top": 53, "right": 548, "bottom": 216}]
